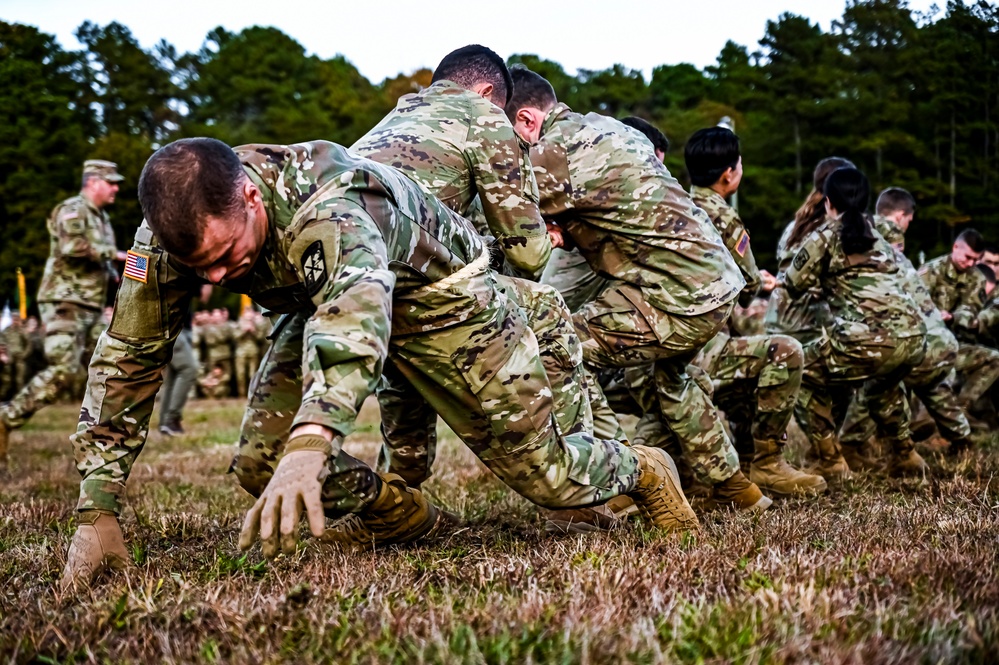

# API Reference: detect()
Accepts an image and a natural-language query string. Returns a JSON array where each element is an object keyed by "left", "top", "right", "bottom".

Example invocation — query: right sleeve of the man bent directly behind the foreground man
[{"left": 465, "top": 104, "right": 552, "bottom": 279}]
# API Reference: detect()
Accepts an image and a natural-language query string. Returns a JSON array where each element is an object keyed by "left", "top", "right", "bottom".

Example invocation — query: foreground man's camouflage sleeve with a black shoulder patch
[{"left": 288, "top": 198, "right": 395, "bottom": 436}]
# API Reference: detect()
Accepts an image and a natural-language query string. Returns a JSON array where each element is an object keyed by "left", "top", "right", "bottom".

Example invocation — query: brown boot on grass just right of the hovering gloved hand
[{"left": 324, "top": 473, "right": 456, "bottom": 550}]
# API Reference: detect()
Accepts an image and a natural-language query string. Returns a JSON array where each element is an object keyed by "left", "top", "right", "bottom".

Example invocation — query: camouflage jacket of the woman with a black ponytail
[{"left": 784, "top": 217, "right": 926, "bottom": 348}]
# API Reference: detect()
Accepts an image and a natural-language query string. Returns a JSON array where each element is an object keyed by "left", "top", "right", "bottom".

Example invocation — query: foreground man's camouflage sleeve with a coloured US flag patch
[{"left": 70, "top": 225, "right": 202, "bottom": 513}]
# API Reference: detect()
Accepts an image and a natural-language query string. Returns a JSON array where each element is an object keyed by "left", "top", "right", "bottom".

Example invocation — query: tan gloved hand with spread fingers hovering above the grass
[{"left": 239, "top": 434, "right": 332, "bottom": 559}]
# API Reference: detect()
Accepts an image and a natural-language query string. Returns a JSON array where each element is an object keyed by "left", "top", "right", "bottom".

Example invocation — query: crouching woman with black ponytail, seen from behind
[{"left": 784, "top": 168, "right": 926, "bottom": 480}]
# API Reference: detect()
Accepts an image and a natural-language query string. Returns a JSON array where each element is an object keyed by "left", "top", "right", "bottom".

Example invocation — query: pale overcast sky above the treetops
[{"left": 0, "top": 0, "right": 946, "bottom": 83}]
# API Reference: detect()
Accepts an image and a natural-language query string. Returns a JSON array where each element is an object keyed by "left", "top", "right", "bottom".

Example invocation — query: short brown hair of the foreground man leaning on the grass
[{"left": 139, "top": 138, "right": 246, "bottom": 258}]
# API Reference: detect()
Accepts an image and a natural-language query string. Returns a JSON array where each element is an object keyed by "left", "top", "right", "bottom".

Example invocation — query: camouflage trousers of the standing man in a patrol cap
[{"left": 0, "top": 302, "right": 101, "bottom": 429}]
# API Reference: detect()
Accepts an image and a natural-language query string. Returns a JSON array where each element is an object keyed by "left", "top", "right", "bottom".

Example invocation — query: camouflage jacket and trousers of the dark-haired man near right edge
[{"left": 919, "top": 254, "right": 999, "bottom": 407}]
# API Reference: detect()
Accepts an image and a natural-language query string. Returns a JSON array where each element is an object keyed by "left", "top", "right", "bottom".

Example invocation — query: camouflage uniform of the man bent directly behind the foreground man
[{"left": 351, "top": 81, "right": 600, "bottom": 485}]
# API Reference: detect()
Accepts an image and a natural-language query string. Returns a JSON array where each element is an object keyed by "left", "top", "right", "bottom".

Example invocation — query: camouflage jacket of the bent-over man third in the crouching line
[{"left": 531, "top": 104, "right": 746, "bottom": 316}]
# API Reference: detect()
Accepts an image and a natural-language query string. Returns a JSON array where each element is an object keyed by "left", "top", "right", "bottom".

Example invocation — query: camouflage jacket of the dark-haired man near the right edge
[{"left": 919, "top": 254, "right": 985, "bottom": 342}]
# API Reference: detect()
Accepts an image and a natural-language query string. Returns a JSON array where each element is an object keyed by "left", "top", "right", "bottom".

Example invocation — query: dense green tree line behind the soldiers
[{"left": 0, "top": 0, "right": 999, "bottom": 306}]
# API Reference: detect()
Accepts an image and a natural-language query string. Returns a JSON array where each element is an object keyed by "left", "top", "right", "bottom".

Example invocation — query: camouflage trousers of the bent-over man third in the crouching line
[{"left": 573, "top": 281, "right": 739, "bottom": 484}]
